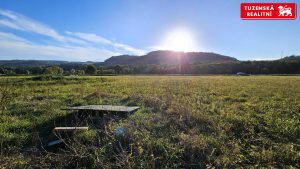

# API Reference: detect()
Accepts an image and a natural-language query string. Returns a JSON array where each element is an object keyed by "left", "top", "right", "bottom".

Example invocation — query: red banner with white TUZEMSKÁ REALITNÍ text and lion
[{"left": 241, "top": 3, "right": 297, "bottom": 20}]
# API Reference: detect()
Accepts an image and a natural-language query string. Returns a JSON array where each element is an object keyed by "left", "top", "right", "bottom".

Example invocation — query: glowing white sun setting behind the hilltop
[{"left": 159, "top": 28, "right": 199, "bottom": 52}]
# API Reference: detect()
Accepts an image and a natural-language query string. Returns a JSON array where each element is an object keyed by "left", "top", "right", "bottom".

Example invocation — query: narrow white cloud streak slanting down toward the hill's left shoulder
[{"left": 66, "top": 31, "right": 145, "bottom": 55}]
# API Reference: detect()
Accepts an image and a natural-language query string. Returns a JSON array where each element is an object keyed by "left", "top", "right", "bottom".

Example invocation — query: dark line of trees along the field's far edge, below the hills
[{"left": 0, "top": 56, "right": 300, "bottom": 75}]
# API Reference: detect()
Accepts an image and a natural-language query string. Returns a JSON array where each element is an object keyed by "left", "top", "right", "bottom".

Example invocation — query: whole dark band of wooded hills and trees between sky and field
[{"left": 0, "top": 51, "right": 300, "bottom": 75}]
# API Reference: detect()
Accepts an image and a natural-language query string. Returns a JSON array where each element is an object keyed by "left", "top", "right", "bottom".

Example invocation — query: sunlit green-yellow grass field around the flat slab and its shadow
[{"left": 0, "top": 76, "right": 300, "bottom": 168}]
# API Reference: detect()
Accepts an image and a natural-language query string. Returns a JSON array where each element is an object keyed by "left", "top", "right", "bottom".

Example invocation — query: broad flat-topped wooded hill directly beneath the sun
[{"left": 104, "top": 50, "right": 237, "bottom": 66}]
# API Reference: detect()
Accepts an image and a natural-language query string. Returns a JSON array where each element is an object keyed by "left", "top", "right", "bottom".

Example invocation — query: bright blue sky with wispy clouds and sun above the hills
[{"left": 0, "top": 0, "right": 300, "bottom": 61}]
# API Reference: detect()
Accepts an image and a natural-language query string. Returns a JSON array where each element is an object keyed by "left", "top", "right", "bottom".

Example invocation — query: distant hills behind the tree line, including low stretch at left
[{"left": 0, "top": 50, "right": 237, "bottom": 67}]
